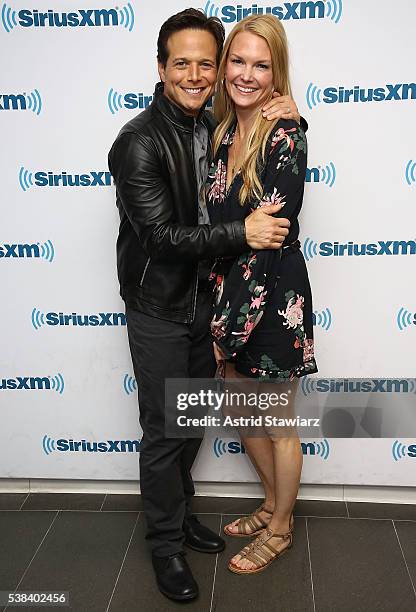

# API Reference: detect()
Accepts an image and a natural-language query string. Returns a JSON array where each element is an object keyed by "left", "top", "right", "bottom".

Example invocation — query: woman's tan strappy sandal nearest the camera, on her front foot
[{"left": 228, "top": 529, "right": 293, "bottom": 574}]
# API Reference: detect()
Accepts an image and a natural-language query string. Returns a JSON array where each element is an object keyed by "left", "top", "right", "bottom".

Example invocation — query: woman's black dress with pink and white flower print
[{"left": 207, "top": 119, "right": 318, "bottom": 382}]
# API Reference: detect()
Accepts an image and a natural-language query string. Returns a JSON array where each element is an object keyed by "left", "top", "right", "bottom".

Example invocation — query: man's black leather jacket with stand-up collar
[{"left": 109, "top": 84, "right": 249, "bottom": 323}]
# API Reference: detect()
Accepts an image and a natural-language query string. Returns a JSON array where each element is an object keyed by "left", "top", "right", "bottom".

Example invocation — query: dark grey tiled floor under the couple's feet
[{"left": 0, "top": 493, "right": 416, "bottom": 612}]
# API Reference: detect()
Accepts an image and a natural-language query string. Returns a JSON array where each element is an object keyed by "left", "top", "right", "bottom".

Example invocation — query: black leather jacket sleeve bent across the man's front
[{"left": 109, "top": 132, "right": 248, "bottom": 259}]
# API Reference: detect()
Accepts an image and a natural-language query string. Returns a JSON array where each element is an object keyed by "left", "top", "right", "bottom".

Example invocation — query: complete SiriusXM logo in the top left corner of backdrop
[{"left": 1, "top": 2, "right": 134, "bottom": 32}]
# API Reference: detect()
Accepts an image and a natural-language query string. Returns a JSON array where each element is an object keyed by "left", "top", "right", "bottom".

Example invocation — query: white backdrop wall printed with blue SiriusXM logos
[{"left": 0, "top": 0, "right": 416, "bottom": 486}]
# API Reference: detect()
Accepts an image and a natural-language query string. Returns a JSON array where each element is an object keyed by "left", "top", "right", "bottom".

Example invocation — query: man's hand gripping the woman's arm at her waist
[{"left": 245, "top": 204, "right": 290, "bottom": 250}]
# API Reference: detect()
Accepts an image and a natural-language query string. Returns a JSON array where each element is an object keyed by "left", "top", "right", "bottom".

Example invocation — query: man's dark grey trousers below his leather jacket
[{"left": 126, "top": 292, "right": 215, "bottom": 556}]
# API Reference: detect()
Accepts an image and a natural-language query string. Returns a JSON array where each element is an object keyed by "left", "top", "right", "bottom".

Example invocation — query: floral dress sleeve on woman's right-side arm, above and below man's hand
[{"left": 211, "top": 121, "right": 307, "bottom": 359}]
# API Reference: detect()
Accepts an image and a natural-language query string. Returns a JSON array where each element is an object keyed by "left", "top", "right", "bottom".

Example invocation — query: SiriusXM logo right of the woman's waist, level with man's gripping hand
[{"left": 303, "top": 238, "right": 416, "bottom": 261}]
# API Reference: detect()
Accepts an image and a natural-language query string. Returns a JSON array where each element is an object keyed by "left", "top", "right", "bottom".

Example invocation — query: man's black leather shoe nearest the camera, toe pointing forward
[{"left": 152, "top": 553, "right": 199, "bottom": 601}]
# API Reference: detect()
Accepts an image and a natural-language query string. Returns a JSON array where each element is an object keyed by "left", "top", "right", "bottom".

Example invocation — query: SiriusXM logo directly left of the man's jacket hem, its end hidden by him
[{"left": 31, "top": 308, "right": 126, "bottom": 330}]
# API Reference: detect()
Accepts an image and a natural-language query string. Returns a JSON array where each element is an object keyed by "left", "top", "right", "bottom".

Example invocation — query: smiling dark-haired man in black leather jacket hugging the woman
[{"left": 109, "top": 9, "right": 297, "bottom": 600}]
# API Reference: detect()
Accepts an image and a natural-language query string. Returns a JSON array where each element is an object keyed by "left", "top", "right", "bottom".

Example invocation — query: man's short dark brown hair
[{"left": 157, "top": 8, "right": 225, "bottom": 66}]
